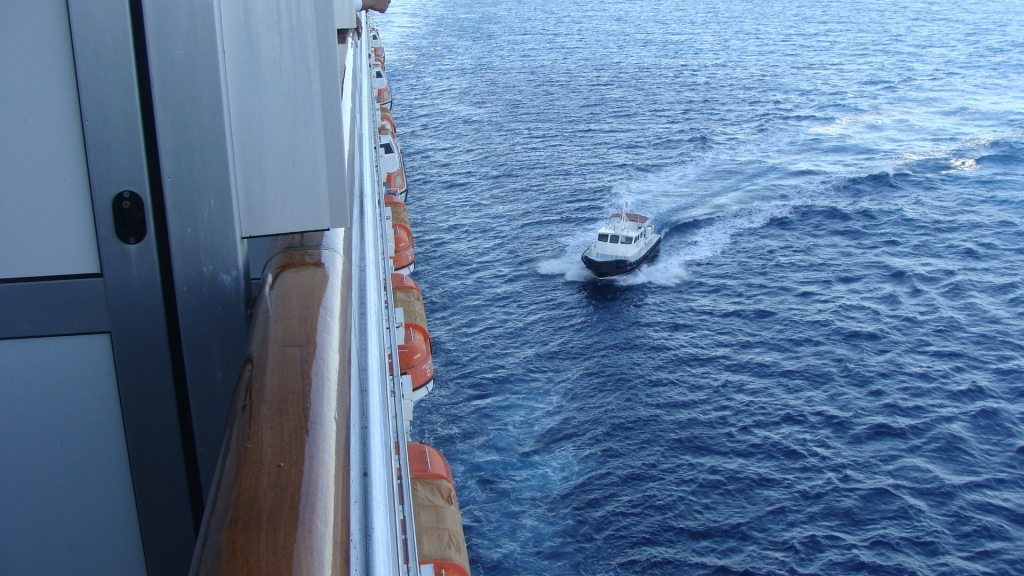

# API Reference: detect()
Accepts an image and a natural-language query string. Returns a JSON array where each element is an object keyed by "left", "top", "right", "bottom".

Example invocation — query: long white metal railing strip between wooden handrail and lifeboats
[{"left": 346, "top": 14, "right": 419, "bottom": 576}]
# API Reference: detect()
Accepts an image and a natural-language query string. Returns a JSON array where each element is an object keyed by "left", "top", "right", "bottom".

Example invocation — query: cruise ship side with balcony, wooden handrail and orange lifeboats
[{"left": 0, "top": 5, "right": 469, "bottom": 576}]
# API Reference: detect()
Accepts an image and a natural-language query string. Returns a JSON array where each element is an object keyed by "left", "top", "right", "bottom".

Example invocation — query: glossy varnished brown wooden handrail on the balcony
[{"left": 191, "top": 230, "right": 351, "bottom": 576}]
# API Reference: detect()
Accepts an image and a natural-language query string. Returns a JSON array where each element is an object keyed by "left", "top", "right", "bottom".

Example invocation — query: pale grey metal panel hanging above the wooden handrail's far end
[{"left": 220, "top": 0, "right": 343, "bottom": 237}]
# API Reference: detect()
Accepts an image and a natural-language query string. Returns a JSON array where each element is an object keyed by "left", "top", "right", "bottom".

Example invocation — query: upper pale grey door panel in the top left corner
[{"left": 0, "top": 0, "right": 99, "bottom": 278}]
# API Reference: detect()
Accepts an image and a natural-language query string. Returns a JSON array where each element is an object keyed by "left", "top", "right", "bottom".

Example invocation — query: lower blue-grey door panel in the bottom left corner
[{"left": 0, "top": 334, "right": 148, "bottom": 576}]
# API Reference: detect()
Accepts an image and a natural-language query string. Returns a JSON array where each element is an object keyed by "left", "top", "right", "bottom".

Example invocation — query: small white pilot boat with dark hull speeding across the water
[{"left": 583, "top": 203, "right": 662, "bottom": 278}]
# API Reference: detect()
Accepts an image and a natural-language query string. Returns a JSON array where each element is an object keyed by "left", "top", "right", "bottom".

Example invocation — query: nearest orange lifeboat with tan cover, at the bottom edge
[{"left": 409, "top": 442, "right": 469, "bottom": 576}]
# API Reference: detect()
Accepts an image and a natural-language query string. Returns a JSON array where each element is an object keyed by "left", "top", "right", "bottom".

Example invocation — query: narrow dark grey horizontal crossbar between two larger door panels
[{"left": 0, "top": 278, "right": 111, "bottom": 339}]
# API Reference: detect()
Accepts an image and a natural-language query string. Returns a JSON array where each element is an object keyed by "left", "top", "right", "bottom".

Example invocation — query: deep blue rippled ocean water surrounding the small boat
[{"left": 377, "top": 0, "right": 1024, "bottom": 576}]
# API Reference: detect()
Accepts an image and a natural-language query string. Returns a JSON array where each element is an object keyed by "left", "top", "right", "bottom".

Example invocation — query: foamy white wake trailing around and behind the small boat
[{"left": 537, "top": 115, "right": 1015, "bottom": 286}]
